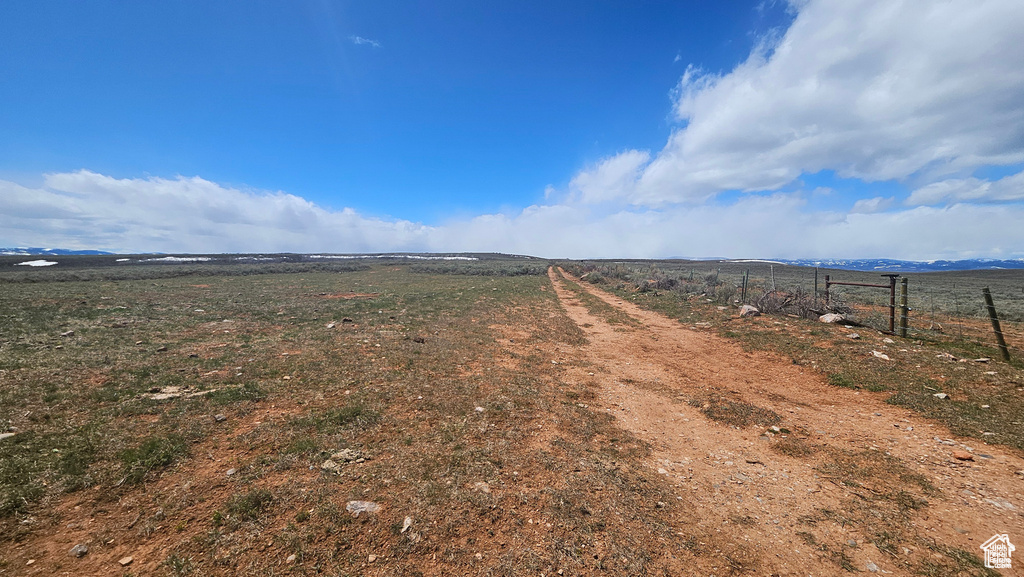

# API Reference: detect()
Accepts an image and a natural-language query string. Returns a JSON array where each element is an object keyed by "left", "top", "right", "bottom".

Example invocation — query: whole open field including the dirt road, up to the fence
[{"left": 0, "top": 257, "right": 1024, "bottom": 576}]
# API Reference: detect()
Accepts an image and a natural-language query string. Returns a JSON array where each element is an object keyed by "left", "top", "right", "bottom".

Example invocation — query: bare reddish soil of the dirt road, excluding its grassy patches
[{"left": 549, "top": 270, "right": 1024, "bottom": 575}]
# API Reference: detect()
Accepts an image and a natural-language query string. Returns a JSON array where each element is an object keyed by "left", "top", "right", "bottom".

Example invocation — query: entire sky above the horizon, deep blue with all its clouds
[{"left": 0, "top": 0, "right": 1024, "bottom": 259}]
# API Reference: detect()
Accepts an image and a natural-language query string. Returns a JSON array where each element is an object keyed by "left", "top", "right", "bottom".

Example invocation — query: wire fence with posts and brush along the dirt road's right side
[{"left": 581, "top": 260, "right": 1024, "bottom": 358}]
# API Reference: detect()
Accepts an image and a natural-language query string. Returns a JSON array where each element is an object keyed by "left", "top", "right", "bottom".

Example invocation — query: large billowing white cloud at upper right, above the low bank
[{"left": 573, "top": 0, "right": 1024, "bottom": 206}]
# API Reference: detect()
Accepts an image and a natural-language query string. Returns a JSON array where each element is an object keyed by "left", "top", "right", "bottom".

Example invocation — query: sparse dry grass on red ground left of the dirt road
[{"left": 0, "top": 264, "right": 720, "bottom": 575}]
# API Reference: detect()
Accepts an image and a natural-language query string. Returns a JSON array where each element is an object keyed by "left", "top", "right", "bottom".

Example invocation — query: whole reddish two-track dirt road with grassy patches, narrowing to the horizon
[{"left": 549, "top": 270, "right": 1024, "bottom": 575}]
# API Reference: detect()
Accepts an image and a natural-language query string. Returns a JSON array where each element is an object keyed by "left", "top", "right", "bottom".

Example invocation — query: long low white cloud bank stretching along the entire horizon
[{"left": 0, "top": 170, "right": 1024, "bottom": 259}]
